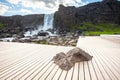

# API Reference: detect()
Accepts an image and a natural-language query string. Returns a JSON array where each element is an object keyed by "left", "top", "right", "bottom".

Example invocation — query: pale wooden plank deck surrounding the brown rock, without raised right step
[{"left": 0, "top": 37, "right": 120, "bottom": 80}]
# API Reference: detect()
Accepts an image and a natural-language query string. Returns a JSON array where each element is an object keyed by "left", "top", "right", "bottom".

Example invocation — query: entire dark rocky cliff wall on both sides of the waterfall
[{"left": 0, "top": 0, "right": 120, "bottom": 37}]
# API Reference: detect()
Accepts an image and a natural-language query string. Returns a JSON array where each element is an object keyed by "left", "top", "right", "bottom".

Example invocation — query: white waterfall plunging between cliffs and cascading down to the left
[{"left": 24, "top": 13, "right": 54, "bottom": 36}]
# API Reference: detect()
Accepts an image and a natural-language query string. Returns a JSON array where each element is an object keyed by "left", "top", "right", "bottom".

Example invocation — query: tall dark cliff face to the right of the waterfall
[{"left": 54, "top": 0, "right": 120, "bottom": 31}]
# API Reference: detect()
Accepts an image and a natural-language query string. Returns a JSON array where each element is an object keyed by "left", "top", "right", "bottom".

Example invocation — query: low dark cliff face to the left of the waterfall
[{"left": 0, "top": 14, "right": 44, "bottom": 37}]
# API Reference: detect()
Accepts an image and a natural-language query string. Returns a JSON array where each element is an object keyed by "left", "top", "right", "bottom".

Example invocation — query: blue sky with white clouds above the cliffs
[{"left": 0, "top": 0, "right": 102, "bottom": 16}]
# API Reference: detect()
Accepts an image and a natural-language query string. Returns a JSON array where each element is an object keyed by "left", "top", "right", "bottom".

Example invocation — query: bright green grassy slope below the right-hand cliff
[{"left": 72, "top": 22, "right": 120, "bottom": 36}]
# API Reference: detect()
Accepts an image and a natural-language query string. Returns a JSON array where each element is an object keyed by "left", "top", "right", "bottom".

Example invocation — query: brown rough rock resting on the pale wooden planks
[{"left": 52, "top": 48, "right": 92, "bottom": 71}]
